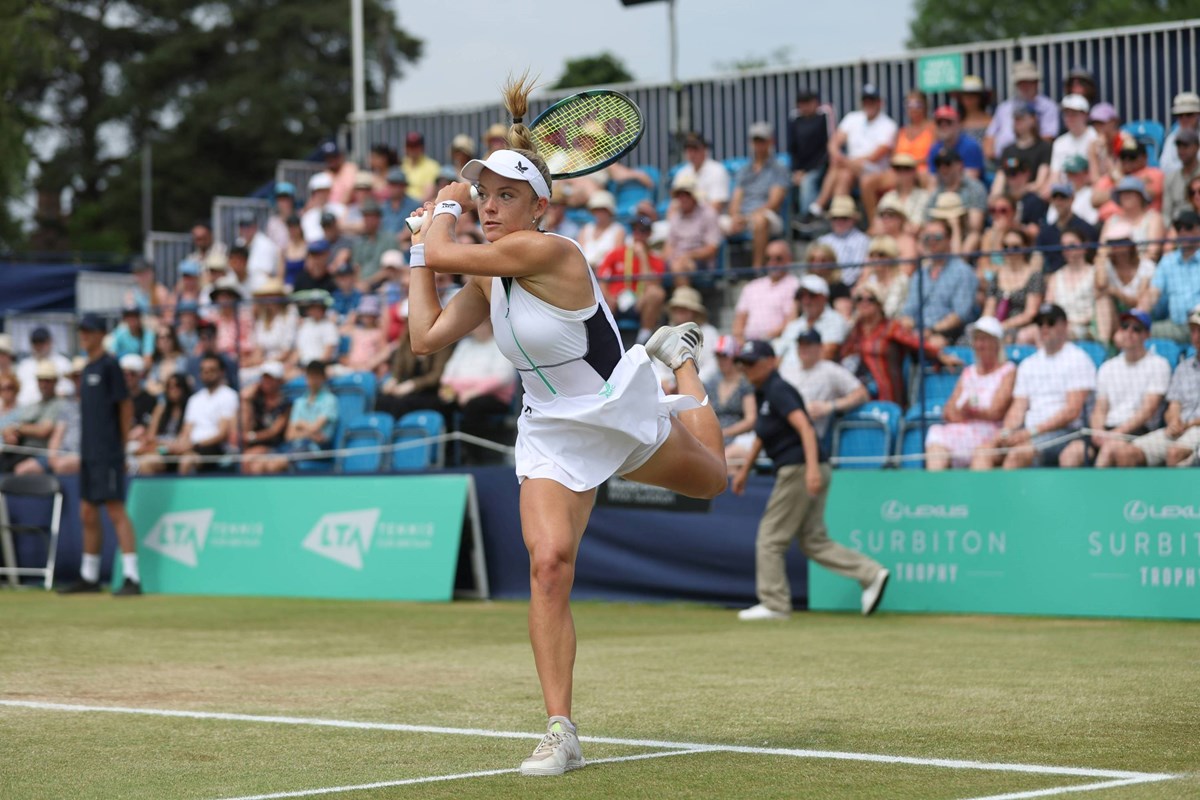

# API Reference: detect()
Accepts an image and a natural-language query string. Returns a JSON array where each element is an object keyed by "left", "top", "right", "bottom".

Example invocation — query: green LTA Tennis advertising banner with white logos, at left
[{"left": 124, "top": 475, "right": 472, "bottom": 601}]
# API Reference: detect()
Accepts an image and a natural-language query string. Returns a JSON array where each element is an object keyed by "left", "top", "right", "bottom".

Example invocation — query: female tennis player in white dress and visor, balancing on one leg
[{"left": 408, "top": 78, "right": 726, "bottom": 775}]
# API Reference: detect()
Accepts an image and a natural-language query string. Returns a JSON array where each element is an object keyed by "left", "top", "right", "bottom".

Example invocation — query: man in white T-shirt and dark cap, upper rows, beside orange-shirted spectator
[{"left": 809, "top": 84, "right": 899, "bottom": 217}]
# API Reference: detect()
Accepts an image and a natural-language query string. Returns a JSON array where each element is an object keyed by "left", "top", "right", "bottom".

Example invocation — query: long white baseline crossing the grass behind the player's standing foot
[{"left": 0, "top": 700, "right": 1178, "bottom": 800}]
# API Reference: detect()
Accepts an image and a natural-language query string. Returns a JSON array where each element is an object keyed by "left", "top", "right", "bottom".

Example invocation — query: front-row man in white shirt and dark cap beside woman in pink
[{"left": 971, "top": 303, "right": 1096, "bottom": 470}]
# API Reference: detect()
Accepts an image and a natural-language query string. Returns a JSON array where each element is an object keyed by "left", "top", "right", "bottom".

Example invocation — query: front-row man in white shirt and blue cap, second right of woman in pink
[{"left": 1058, "top": 308, "right": 1171, "bottom": 467}]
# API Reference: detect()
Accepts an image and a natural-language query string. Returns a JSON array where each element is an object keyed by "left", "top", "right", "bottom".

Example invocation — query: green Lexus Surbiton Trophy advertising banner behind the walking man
[{"left": 809, "top": 469, "right": 1200, "bottom": 619}]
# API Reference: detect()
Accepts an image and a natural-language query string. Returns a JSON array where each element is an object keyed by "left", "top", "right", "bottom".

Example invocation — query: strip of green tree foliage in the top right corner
[{"left": 908, "top": 0, "right": 1200, "bottom": 48}]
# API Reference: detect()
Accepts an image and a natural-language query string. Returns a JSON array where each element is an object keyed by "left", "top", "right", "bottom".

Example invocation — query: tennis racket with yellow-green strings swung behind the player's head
[{"left": 406, "top": 89, "right": 646, "bottom": 233}]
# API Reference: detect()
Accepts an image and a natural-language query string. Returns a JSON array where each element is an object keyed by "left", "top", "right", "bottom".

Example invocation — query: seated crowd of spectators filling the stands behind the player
[{"left": 7, "top": 62, "right": 1200, "bottom": 474}]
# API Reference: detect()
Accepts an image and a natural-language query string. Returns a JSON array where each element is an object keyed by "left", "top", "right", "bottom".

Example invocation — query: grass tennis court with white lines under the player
[{"left": 0, "top": 591, "right": 1200, "bottom": 800}]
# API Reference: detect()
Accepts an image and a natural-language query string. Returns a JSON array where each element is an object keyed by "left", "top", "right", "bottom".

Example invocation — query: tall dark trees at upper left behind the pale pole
[{"left": 7, "top": 0, "right": 421, "bottom": 249}]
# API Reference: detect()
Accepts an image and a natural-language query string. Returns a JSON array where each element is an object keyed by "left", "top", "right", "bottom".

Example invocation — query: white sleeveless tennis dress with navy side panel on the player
[{"left": 492, "top": 234, "right": 700, "bottom": 492}]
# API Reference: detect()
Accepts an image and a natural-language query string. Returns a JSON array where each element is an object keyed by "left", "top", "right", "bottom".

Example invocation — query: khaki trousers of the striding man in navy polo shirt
[{"left": 755, "top": 464, "right": 883, "bottom": 612}]
